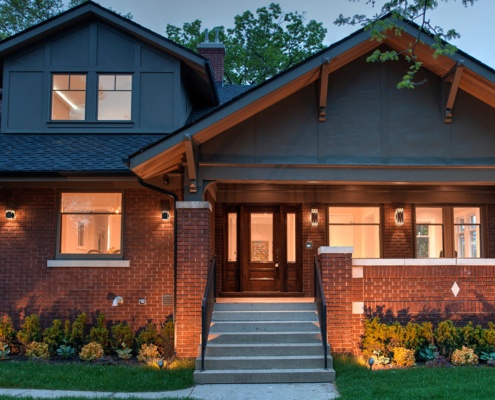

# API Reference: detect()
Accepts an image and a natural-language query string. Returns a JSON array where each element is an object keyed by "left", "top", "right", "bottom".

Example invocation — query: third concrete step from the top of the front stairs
[{"left": 210, "top": 321, "right": 320, "bottom": 334}]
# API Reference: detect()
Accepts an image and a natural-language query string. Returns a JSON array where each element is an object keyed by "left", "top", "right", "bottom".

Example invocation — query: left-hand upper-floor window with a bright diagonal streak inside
[{"left": 51, "top": 74, "right": 86, "bottom": 121}]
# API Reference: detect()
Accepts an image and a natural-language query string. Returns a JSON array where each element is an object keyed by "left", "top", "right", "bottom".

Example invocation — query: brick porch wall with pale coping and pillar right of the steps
[{"left": 319, "top": 247, "right": 495, "bottom": 354}]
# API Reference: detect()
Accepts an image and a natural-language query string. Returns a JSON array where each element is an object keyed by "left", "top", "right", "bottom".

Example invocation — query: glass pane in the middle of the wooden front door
[{"left": 250, "top": 213, "right": 273, "bottom": 262}]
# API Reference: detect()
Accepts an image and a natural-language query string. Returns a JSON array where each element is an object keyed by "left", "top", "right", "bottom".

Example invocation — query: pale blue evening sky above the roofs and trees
[{"left": 96, "top": 0, "right": 495, "bottom": 68}]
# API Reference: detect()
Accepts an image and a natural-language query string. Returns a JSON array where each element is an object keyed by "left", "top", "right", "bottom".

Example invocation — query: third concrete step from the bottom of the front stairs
[{"left": 206, "top": 340, "right": 323, "bottom": 357}]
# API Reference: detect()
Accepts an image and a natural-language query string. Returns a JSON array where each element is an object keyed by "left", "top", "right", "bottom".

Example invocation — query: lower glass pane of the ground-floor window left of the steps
[{"left": 60, "top": 214, "right": 122, "bottom": 254}]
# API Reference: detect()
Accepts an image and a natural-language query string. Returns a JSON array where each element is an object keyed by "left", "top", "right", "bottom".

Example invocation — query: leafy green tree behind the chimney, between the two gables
[{"left": 166, "top": 3, "right": 327, "bottom": 84}]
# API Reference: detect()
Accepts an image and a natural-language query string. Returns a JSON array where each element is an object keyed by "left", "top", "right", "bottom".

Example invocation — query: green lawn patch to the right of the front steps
[{"left": 334, "top": 356, "right": 495, "bottom": 400}]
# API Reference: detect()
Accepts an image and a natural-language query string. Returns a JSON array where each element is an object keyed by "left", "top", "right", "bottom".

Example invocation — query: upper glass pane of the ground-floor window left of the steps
[{"left": 61, "top": 193, "right": 122, "bottom": 214}]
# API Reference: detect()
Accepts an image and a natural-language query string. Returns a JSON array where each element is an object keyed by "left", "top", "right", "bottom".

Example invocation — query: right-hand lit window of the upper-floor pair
[{"left": 98, "top": 75, "right": 132, "bottom": 121}]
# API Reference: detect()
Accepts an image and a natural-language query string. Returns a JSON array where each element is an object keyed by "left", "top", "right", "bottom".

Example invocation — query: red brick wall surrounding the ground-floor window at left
[{"left": 0, "top": 188, "right": 174, "bottom": 328}]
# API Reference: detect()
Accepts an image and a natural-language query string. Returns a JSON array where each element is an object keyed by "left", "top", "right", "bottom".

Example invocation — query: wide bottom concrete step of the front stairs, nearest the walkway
[{"left": 194, "top": 368, "right": 335, "bottom": 384}]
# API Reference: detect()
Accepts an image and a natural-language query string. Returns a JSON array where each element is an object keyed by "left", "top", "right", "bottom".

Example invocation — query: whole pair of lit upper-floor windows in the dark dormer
[{"left": 51, "top": 73, "right": 132, "bottom": 122}]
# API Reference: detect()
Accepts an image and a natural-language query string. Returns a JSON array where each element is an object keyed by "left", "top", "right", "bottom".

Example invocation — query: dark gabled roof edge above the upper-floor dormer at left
[{"left": 0, "top": 1, "right": 219, "bottom": 106}]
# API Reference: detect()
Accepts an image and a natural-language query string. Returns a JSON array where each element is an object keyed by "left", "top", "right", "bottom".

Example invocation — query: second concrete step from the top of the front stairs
[{"left": 212, "top": 310, "right": 318, "bottom": 322}]
